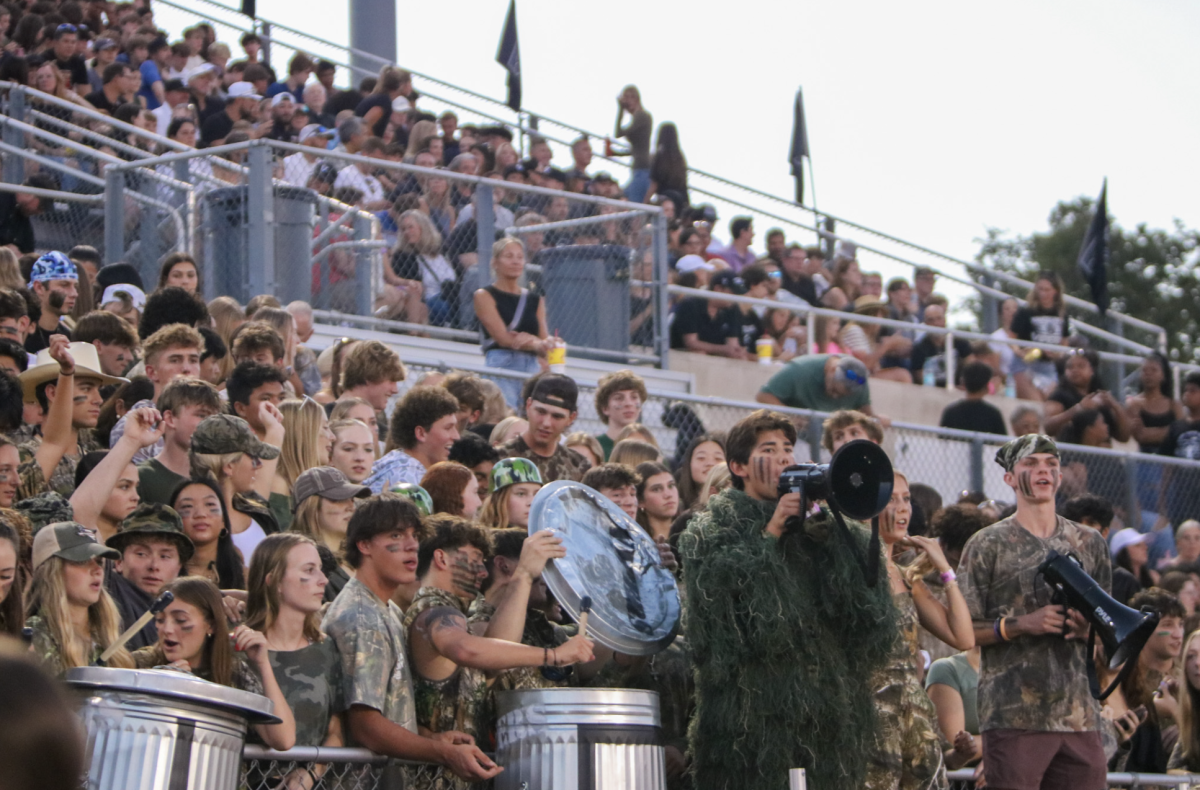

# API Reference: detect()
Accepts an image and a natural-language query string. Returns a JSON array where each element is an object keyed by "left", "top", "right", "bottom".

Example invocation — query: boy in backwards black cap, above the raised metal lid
[{"left": 500, "top": 373, "right": 589, "bottom": 483}]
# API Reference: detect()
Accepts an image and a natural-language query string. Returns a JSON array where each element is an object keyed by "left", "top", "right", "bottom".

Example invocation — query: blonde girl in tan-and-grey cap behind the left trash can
[{"left": 26, "top": 521, "right": 133, "bottom": 678}]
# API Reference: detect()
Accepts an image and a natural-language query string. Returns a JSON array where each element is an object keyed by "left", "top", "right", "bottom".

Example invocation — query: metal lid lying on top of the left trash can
[{"left": 66, "top": 666, "right": 282, "bottom": 724}]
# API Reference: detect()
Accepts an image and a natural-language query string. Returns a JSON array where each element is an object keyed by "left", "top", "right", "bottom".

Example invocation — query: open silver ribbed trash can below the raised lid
[{"left": 494, "top": 688, "right": 667, "bottom": 790}]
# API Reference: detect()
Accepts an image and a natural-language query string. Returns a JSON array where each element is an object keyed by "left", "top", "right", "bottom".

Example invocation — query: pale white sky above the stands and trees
[{"left": 156, "top": 0, "right": 1200, "bottom": 314}]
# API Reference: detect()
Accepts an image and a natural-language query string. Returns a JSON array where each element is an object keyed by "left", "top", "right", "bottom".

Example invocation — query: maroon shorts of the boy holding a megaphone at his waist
[{"left": 983, "top": 730, "right": 1108, "bottom": 790}]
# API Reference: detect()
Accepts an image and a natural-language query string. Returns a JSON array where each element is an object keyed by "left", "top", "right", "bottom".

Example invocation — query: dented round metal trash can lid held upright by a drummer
[{"left": 529, "top": 480, "right": 679, "bottom": 656}]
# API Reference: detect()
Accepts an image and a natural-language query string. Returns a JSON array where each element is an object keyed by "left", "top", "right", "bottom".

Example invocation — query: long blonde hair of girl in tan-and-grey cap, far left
[{"left": 30, "top": 557, "right": 133, "bottom": 675}]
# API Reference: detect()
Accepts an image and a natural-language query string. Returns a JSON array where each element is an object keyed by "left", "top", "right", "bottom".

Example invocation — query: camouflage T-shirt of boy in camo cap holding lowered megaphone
[{"left": 958, "top": 516, "right": 1112, "bottom": 732}]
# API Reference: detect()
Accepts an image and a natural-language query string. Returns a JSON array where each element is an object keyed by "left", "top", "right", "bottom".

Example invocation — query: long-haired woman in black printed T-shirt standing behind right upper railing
[{"left": 1013, "top": 271, "right": 1070, "bottom": 401}]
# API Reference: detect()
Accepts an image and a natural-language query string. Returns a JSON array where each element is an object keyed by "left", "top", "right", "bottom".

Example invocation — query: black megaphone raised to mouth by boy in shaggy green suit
[{"left": 779, "top": 439, "right": 895, "bottom": 521}]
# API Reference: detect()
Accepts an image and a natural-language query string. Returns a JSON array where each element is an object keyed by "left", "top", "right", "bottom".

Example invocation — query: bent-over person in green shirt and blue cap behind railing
[{"left": 755, "top": 354, "right": 874, "bottom": 417}]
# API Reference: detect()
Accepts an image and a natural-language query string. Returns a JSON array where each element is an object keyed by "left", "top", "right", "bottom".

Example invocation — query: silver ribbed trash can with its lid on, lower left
[{"left": 66, "top": 666, "right": 280, "bottom": 790}]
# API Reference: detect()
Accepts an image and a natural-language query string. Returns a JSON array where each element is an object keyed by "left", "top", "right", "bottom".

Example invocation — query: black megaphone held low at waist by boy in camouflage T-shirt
[{"left": 1038, "top": 551, "right": 1159, "bottom": 699}]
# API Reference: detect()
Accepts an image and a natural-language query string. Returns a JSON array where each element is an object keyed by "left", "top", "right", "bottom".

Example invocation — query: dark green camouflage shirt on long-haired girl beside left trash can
[{"left": 270, "top": 639, "right": 346, "bottom": 746}]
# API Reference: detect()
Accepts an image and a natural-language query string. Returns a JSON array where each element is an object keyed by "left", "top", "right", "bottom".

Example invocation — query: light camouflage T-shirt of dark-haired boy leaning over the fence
[{"left": 320, "top": 571, "right": 416, "bottom": 732}]
